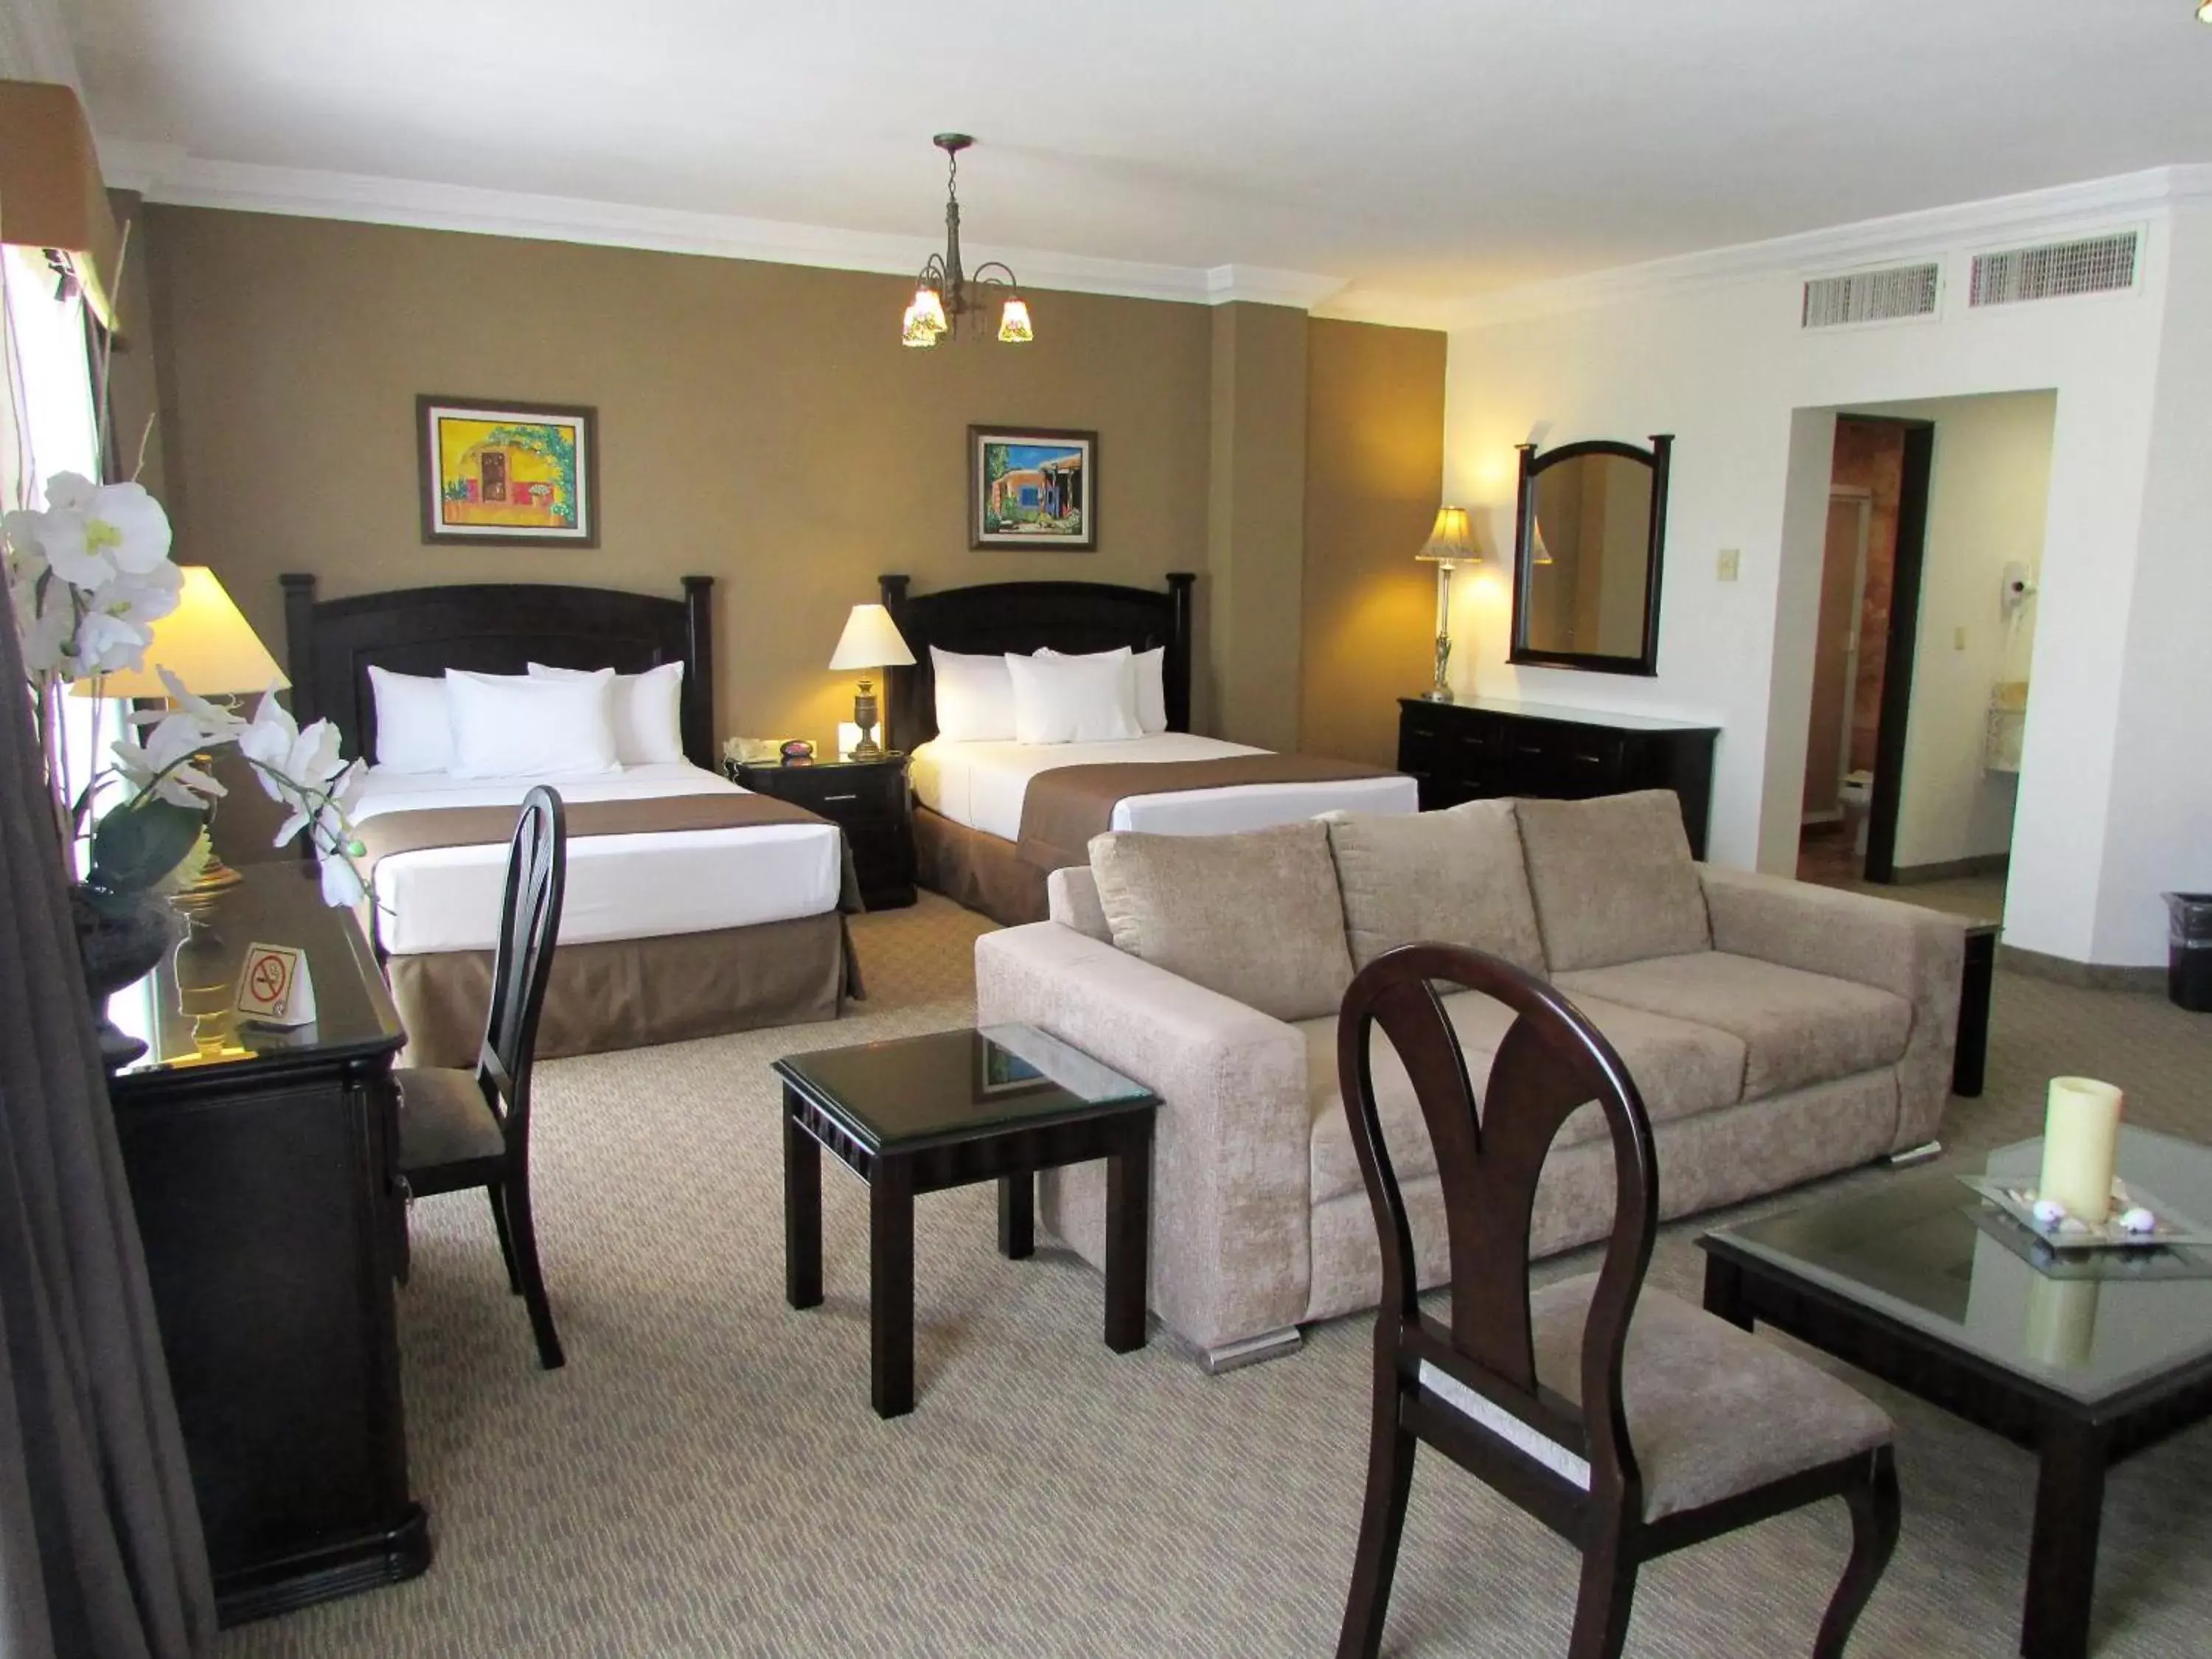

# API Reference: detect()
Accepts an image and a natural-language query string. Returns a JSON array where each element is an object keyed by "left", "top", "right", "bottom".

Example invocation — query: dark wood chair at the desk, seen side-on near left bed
[{"left": 396, "top": 785, "right": 568, "bottom": 1371}]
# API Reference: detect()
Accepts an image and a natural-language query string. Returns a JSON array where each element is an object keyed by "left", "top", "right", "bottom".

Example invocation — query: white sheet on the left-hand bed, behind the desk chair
[{"left": 354, "top": 761, "right": 841, "bottom": 956}]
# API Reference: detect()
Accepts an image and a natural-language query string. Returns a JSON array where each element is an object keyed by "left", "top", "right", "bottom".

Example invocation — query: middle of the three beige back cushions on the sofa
[{"left": 1321, "top": 801, "right": 1544, "bottom": 973}]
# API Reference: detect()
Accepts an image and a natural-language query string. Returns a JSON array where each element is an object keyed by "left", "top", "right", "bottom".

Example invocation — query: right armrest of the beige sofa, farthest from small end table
[{"left": 1699, "top": 865, "right": 1966, "bottom": 1150}]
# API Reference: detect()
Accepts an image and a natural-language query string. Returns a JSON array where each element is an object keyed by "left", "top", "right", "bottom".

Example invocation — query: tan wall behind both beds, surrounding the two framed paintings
[{"left": 135, "top": 206, "right": 1210, "bottom": 741}]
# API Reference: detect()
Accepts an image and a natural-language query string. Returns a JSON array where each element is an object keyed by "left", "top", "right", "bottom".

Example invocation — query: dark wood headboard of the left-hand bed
[{"left": 281, "top": 573, "right": 719, "bottom": 770}]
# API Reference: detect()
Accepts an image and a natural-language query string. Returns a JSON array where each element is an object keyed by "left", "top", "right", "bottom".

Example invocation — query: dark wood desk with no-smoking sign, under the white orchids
[{"left": 108, "top": 860, "right": 429, "bottom": 1624}]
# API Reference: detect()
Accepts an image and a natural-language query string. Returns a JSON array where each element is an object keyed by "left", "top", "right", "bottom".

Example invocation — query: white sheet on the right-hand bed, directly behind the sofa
[{"left": 909, "top": 732, "right": 1420, "bottom": 841}]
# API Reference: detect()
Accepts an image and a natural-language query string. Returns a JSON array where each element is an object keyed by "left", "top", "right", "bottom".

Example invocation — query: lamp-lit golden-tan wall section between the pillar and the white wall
[{"left": 1298, "top": 319, "right": 1451, "bottom": 765}]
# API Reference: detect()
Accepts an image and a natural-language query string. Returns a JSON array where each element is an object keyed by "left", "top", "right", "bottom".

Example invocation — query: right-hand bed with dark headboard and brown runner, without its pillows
[{"left": 880, "top": 573, "right": 1418, "bottom": 925}]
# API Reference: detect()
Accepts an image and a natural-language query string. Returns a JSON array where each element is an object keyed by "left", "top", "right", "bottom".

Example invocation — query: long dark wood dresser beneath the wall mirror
[{"left": 1398, "top": 697, "right": 1721, "bottom": 858}]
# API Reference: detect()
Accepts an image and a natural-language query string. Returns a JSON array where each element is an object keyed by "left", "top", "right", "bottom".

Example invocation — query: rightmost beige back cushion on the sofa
[{"left": 1515, "top": 790, "right": 1712, "bottom": 973}]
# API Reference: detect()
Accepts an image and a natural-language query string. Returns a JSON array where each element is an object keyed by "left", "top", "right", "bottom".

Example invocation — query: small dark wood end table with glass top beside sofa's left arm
[{"left": 774, "top": 1026, "right": 1159, "bottom": 1418}]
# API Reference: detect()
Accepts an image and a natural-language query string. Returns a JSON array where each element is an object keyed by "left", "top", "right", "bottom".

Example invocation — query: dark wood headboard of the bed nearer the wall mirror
[{"left": 876, "top": 571, "right": 1197, "bottom": 750}]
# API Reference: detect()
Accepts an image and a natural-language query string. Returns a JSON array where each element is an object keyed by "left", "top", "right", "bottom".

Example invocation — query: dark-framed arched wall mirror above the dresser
[{"left": 1509, "top": 434, "right": 1674, "bottom": 675}]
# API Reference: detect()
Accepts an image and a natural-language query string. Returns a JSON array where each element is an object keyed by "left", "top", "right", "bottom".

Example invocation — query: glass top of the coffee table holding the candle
[{"left": 1708, "top": 1128, "right": 2212, "bottom": 1402}]
